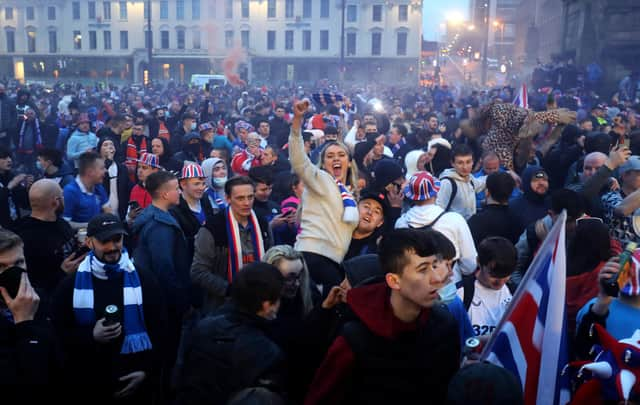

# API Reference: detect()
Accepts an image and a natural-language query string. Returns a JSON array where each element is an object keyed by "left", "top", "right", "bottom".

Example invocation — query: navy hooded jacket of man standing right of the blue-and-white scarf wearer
[{"left": 133, "top": 205, "right": 191, "bottom": 315}]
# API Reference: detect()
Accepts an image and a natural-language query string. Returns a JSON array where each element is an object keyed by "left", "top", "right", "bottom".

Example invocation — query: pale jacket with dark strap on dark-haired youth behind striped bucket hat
[{"left": 436, "top": 169, "right": 487, "bottom": 219}]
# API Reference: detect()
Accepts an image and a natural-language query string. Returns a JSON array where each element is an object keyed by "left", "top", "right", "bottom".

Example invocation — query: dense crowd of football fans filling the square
[{"left": 0, "top": 74, "right": 640, "bottom": 405}]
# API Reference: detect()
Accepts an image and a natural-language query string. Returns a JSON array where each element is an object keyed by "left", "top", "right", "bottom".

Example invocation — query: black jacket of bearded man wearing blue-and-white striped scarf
[{"left": 52, "top": 270, "right": 167, "bottom": 403}]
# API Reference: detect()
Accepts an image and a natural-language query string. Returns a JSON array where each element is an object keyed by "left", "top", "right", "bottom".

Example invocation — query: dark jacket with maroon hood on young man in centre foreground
[{"left": 305, "top": 283, "right": 460, "bottom": 405}]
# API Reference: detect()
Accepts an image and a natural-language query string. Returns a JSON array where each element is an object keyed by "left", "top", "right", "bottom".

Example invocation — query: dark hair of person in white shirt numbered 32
[{"left": 478, "top": 236, "right": 518, "bottom": 278}]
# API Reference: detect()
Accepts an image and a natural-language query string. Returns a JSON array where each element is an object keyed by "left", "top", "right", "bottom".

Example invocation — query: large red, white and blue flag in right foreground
[{"left": 482, "top": 211, "right": 569, "bottom": 405}]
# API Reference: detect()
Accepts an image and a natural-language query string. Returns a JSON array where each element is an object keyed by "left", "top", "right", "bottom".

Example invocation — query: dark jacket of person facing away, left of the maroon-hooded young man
[{"left": 177, "top": 308, "right": 284, "bottom": 405}]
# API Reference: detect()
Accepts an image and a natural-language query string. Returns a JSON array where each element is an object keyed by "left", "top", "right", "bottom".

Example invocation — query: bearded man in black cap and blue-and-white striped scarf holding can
[{"left": 52, "top": 214, "right": 167, "bottom": 404}]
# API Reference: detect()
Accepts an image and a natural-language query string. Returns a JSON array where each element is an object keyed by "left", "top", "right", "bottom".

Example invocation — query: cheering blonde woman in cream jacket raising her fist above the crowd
[{"left": 289, "top": 100, "right": 359, "bottom": 292}]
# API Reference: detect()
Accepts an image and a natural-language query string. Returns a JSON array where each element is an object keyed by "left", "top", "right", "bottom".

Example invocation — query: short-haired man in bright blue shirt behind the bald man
[{"left": 63, "top": 152, "right": 111, "bottom": 229}]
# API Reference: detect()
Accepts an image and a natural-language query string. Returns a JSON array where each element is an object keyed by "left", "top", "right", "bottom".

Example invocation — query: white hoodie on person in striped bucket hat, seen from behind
[{"left": 396, "top": 204, "right": 478, "bottom": 282}]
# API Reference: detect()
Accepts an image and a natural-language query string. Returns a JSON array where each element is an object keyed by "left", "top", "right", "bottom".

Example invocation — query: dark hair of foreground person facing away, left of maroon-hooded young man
[{"left": 231, "top": 262, "right": 284, "bottom": 315}]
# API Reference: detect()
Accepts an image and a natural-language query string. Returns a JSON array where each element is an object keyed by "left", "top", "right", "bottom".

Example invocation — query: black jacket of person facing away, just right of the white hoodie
[{"left": 467, "top": 204, "right": 520, "bottom": 246}]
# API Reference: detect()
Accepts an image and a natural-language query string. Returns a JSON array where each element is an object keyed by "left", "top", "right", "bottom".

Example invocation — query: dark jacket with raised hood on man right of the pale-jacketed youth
[{"left": 509, "top": 166, "right": 549, "bottom": 234}]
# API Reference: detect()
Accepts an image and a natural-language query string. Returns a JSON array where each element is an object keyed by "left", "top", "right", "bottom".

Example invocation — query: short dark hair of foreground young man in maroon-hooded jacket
[{"left": 378, "top": 229, "right": 438, "bottom": 274}]
